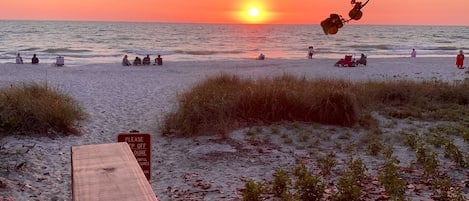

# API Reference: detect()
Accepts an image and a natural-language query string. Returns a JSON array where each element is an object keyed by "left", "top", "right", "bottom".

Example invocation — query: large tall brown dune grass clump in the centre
[{"left": 163, "top": 75, "right": 358, "bottom": 136}]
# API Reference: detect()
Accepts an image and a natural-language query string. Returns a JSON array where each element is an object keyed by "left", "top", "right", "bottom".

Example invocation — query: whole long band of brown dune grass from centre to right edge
[{"left": 162, "top": 74, "right": 469, "bottom": 137}]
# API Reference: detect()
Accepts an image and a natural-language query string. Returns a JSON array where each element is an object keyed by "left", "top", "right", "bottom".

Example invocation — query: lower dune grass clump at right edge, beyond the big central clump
[{"left": 355, "top": 80, "right": 469, "bottom": 121}]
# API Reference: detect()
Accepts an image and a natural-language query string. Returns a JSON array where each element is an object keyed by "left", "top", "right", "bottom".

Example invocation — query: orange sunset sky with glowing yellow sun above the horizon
[{"left": 0, "top": 0, "right": 469, "bottom": 26}]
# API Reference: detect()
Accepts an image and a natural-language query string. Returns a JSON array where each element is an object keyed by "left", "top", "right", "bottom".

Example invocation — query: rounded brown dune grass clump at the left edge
[{"left": 0, "top": 83, "right": 86, "bottom": 134}]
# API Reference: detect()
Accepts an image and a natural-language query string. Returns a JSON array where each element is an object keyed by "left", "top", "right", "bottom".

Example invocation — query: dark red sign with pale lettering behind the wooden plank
[{"left": 117, "top": 133, "right": 151, "bottom": 181}]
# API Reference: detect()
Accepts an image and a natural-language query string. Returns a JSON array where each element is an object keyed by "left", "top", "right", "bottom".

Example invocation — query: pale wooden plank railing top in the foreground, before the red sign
[{"left": 71, "top": 142, "right": 158, "bottom": 201}]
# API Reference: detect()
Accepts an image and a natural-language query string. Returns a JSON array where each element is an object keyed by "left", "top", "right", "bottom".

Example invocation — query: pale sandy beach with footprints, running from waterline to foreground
[{"left": 0, "top": 57, "right": 469, "bottom": 201}]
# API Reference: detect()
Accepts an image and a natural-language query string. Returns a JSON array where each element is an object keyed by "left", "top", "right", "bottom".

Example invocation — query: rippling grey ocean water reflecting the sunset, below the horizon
[{"left": 0, "top": 21, "right": 469, "bottom": 65}]
